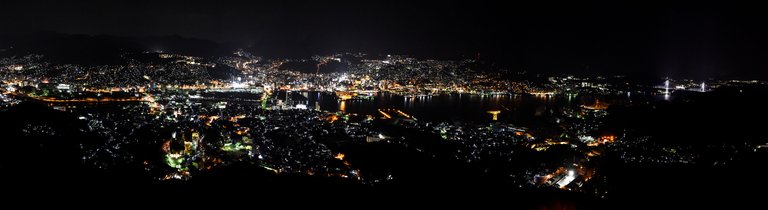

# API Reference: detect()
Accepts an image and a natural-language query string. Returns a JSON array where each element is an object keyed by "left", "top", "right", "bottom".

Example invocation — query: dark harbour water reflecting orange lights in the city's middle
[{"left": 286, "top": 92, "right": 615, "bottom": 123}]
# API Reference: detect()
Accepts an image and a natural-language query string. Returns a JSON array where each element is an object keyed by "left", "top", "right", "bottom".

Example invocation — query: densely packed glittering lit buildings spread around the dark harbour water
[{"left": 0, "top": 51, "right": 761, "bottom": 199}]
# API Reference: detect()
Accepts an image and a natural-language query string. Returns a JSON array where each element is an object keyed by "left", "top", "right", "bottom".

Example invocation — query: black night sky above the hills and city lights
[{"left": 0, "top": 0, "right": 768, "bottom": 78}]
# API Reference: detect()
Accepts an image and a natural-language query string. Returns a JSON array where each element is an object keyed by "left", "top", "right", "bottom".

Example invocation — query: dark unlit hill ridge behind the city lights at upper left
[{"left": 0, "top": 32, "right": 235, "bottom": 65}]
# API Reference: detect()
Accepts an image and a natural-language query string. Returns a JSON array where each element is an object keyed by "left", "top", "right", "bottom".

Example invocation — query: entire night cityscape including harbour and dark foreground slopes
[{"left": 0, "top": 0, "right": 768, "bottom": 209}]
